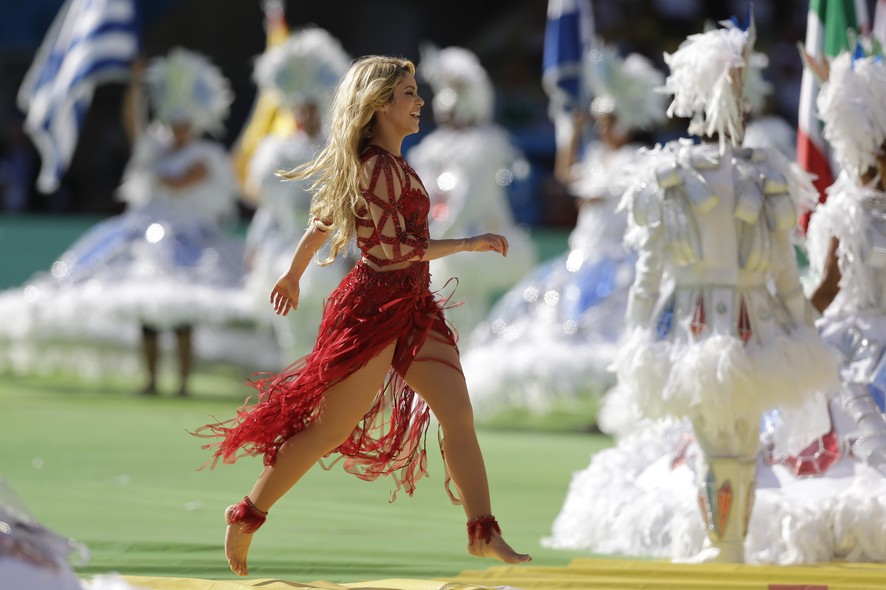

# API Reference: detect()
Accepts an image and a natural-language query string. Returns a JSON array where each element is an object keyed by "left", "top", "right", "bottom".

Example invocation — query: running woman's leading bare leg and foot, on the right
[{"left": 406, "top": 333, "right": 532, "bottom": 563}]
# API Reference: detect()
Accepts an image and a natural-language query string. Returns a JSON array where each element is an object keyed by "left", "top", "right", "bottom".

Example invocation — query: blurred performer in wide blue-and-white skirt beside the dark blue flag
[{"left": 462, "top": 48, "right": 665, "bottom": 417}]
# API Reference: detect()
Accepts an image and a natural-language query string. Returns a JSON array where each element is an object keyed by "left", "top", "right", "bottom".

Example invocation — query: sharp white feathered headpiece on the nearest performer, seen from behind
[{"left": 661, "top": 19, "right": 769, "bottom": 145}]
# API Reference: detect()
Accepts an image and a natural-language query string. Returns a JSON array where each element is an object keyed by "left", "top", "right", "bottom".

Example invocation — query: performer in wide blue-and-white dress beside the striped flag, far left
[{"left": 0, "top": 49, "right": 250, "bottom": 385}]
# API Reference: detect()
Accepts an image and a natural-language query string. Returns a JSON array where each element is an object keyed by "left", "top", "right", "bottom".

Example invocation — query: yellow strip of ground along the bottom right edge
[{"left": 452, "top": 559, "right": 886, "bottom": 590}]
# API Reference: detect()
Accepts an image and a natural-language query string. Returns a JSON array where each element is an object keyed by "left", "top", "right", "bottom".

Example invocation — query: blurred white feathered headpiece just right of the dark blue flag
[{"left": 584, "top": 46, "right": 665, "bottom": 131}]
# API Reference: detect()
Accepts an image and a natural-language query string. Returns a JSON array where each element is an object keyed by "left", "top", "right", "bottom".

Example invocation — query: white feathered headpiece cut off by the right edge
[{"left": 817, "top": 52, "right": 886, "bottom": 177}]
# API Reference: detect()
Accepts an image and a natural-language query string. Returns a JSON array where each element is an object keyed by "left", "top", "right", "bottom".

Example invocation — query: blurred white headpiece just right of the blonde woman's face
[{"left": 418, "top": 44, "right": 495, "bottom": 125}]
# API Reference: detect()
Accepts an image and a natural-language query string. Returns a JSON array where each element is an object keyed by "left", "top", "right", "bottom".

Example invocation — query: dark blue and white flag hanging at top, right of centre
[{"left": 542, "top": 0, "right": 594, "bottom": 111}]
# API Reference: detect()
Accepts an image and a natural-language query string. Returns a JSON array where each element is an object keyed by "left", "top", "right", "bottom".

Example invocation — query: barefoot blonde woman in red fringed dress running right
[{"left": 201, "top": 56, "right": 530, "bottom": 575}]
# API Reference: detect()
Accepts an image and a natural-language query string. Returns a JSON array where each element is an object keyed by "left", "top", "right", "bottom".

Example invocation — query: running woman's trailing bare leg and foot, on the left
[{"left": 225, "top": 344, "right": 394, "bottom": 576}]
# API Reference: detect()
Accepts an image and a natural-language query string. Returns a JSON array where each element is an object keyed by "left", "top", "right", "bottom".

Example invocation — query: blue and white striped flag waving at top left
[{"left": 18, "top": 0, "right": 139, "bottom": 193}]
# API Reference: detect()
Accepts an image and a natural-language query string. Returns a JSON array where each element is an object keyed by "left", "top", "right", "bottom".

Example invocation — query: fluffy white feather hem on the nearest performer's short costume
[{"left": 607, "top": 327, "right": 839, "bottom": 444}]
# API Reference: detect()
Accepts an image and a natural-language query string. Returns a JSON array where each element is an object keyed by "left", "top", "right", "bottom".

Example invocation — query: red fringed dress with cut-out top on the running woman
[{"left": 196, "top": 146, "right": 461, "bottom": 501}]
